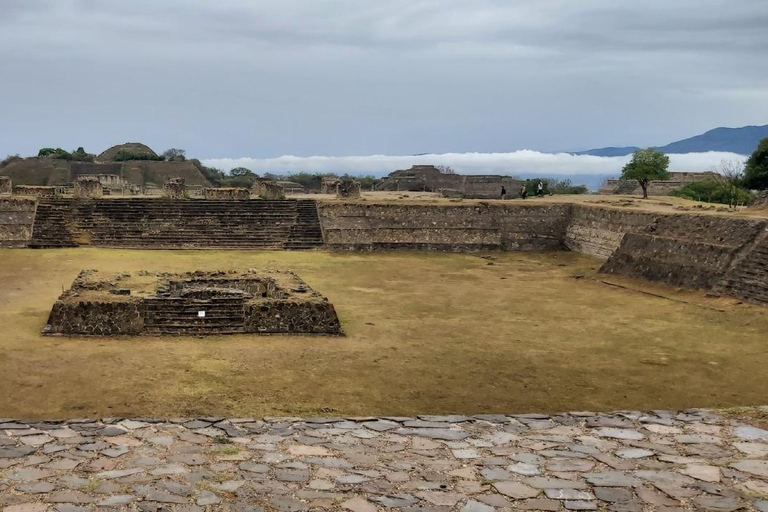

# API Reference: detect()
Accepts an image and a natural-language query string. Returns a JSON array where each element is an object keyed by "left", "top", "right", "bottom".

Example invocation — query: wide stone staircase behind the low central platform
[{"left": 28, "top": 199, "right": 323, "bottom": 250}]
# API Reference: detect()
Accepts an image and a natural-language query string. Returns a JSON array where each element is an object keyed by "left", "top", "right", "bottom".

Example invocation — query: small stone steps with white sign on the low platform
[{"left": 144, "top": 297, "right": 245, "bottom": 336}]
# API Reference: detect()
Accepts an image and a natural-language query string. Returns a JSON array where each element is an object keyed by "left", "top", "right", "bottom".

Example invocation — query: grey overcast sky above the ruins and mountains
[{"left": 0, "top": 0, "right": 768, "bottom": 164}]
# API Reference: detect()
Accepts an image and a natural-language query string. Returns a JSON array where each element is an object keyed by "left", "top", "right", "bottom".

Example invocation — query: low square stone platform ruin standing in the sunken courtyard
[{"left": 43, "top": 270, "right": 344, "bottom": 336}]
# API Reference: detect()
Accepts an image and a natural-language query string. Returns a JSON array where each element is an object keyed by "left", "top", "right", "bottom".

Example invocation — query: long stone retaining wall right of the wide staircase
[{"left": 319, "top": 203, "right": 570, "bottom": 252}]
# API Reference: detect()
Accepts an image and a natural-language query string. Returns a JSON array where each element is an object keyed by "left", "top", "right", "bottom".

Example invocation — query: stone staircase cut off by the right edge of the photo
[{"left": 715, "top": 228, "right": 768, "bottom": 304}]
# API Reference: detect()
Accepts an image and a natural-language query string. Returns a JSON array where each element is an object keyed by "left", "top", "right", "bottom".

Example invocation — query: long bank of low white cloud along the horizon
[{"left": 203, "top": 150, "right": 746, "bottom": 177}]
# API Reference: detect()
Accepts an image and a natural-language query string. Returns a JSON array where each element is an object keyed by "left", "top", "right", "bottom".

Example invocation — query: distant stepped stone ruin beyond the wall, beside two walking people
[{"left": 377, "top": 165, "right": 524, "bottom": 199}]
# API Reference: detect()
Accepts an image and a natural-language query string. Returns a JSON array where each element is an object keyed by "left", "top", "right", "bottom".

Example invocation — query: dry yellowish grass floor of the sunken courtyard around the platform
[{"left": 0, "top": 248, "right": 768, "bottom": 418}]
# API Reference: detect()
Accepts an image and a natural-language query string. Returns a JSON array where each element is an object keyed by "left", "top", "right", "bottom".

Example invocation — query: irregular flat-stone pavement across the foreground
[{"left": 0, "top": 408, "right": 768, "bottom": 512}]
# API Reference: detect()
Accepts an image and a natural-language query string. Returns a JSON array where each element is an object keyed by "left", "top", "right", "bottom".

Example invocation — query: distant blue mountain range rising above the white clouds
[{"left": 573, "top": 124, "right": 768, "bottom": 156}]
